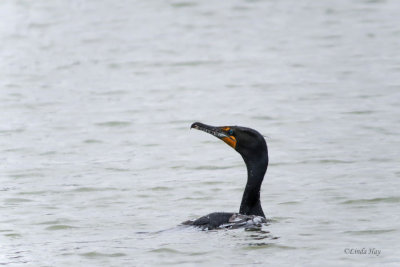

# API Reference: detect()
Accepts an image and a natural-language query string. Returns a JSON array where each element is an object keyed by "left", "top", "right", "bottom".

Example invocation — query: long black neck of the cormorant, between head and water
[{"left": 239, "top": 152, "right": 268, "bottom": 217}]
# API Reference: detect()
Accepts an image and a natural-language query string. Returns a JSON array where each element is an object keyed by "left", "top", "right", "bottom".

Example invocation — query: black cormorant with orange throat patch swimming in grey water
[{"left": 182, "top": 122, "right": 268, "bottom": 230}]
